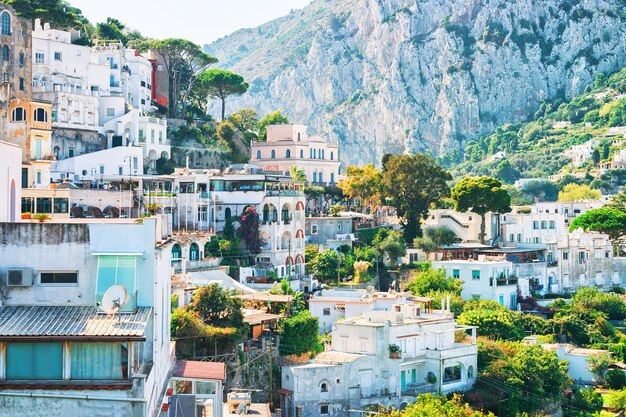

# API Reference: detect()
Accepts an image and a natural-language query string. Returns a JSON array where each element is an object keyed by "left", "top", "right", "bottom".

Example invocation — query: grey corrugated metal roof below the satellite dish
[{"left": 0, "top": 306, "right": 152, "bottom": 340}]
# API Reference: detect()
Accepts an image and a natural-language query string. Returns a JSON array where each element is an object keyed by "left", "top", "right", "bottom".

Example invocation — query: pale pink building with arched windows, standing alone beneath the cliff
[{"left": 250, "top": 125, "right": 340, "bottom": 185}]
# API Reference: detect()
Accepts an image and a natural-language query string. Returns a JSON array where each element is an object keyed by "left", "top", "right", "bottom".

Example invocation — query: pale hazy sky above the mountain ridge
[{"left": 69, "top": 0, "right": 311, "bottom": 45}]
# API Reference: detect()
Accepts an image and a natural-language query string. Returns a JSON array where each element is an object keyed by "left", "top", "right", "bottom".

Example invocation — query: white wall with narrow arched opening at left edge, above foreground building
[{"left": 0, "top": 141, "right": 22, "bottom": 222}]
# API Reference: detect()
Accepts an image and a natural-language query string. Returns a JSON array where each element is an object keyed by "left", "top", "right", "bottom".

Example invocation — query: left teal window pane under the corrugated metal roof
[{"left": 5, "top": 342, "right": 63, "bottom": 380}]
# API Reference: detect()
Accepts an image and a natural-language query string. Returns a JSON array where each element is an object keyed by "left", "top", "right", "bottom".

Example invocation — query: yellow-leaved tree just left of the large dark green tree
[{"left": 337, "top": 164, "right": 383, "bottom": 209}]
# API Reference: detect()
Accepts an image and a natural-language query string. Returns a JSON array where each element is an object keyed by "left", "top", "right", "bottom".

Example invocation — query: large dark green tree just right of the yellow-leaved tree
[{"left": 382, "top": 154, "right": 452, "bottom": 242}]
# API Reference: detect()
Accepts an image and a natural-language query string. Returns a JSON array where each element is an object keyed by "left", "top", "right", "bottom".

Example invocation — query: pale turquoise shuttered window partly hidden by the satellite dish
[{"left": 96, "top": 255, "right": 137, "bottom": 311}]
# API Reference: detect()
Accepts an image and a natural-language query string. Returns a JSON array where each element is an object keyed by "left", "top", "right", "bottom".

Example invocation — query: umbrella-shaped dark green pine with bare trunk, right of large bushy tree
[{"left": 451, "top": 177, "right": 511, "bottom": 243}]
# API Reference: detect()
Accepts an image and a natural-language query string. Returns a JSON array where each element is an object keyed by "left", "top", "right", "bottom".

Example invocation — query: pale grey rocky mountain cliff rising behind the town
[{"left": 206, "top": 0, "right": 626, "bottom": 163}]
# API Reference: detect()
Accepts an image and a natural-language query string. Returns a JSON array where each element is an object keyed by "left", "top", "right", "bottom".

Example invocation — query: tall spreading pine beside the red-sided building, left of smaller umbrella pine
[{"left": 144, "top": 38, "right": 217, "bottom": 117}]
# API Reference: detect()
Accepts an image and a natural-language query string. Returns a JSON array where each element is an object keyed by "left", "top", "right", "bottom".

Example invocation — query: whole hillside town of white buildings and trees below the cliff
[{"left": 0, "top": 1, "right": 626, "bottom": 417}]
